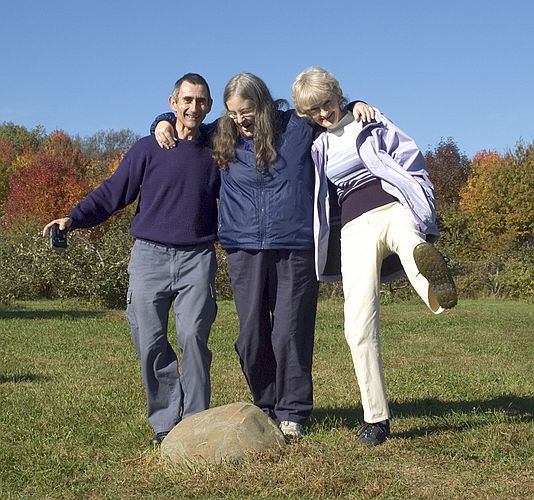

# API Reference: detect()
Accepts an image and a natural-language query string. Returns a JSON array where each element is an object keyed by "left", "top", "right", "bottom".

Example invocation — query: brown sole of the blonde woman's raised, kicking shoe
[{"left": 413, "top": 243, "right": 458, "bottom": 309}]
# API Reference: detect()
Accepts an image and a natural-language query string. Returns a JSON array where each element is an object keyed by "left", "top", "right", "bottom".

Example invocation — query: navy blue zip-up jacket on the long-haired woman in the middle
[{"left": 219, "top": 110, "right": 314, "bottom": 250}]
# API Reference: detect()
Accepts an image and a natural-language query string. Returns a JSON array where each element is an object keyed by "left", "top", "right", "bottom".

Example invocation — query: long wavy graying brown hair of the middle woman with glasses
[{"left": 213, "top": 73, "right": 285, "bottom": 173}]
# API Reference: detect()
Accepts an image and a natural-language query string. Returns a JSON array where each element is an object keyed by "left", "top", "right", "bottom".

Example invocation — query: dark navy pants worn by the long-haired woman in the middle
[{"left": 228, "top": 250, "right": 318, "bottom": 424}]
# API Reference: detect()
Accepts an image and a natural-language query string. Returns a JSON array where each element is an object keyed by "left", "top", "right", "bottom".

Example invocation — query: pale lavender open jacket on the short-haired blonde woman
[{"left": 311, "top": 113, "right": 439, "bottom": 282}]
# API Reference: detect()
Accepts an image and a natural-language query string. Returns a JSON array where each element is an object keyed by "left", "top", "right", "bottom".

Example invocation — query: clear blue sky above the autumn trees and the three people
[{"left": 0, "top": 0, "right": 534, "bottom": 156}]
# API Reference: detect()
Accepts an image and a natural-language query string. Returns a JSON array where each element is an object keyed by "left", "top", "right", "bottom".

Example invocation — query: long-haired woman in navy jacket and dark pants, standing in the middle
[{"left": 213, "top": 73, "right": 318, "bottom": 437}]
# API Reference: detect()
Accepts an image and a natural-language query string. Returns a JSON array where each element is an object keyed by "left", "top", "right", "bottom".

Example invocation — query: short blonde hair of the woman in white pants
[{"left": 291, "top": 66, "right": 347, "bottom": 118}]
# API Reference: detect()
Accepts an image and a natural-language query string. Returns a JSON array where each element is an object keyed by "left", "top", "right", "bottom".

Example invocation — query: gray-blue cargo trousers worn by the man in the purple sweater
[{"left": 127, "top": 240, "right": 217, "bottom": 432}]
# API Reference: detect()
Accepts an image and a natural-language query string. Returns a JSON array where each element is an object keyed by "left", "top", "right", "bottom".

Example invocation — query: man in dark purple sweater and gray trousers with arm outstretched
[{"left": 43, "top": 73, "right": 220, "bottom": 445}]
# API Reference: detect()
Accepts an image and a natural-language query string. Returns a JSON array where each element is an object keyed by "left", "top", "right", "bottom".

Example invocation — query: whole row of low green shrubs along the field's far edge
[{"left": 0, "top": 215, "right": 534, "bottom": 309}]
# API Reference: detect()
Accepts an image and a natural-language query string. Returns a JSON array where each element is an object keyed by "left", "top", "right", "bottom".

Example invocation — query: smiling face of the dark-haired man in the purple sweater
[{"left": 169, "top": 81, "right": 211, "bottom": 131}]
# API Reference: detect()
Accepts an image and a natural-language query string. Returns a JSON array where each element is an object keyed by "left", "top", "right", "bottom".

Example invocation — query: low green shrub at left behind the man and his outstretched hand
[{"left": 0, "top": 217, "right": 236, "bottom": 308}]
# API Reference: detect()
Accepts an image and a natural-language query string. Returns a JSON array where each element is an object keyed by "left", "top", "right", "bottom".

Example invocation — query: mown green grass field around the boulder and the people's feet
[{"left": 0, "top": 300, "right": 534, "bottom": 499}]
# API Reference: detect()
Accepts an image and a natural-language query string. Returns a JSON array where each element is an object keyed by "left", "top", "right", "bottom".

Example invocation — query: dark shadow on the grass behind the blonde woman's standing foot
[{"left": 310, "top": 395, "right": 534, "bottom": 437}]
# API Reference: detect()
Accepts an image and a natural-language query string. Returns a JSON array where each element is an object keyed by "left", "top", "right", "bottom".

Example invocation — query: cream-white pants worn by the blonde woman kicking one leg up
[{"left": 341, "top": 202, "right": 443, "bottom": 423}]
